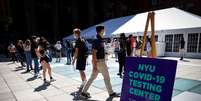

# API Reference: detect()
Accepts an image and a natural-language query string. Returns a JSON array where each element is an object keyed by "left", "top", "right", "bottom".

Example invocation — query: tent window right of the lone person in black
[{"left": 187, "top": 33, "right": 198, "bottom": 53}]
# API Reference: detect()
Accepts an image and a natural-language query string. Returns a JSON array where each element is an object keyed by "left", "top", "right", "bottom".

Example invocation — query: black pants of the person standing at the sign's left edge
[{"left": 118, "top": 52, "right": 126, "bottom": 75}]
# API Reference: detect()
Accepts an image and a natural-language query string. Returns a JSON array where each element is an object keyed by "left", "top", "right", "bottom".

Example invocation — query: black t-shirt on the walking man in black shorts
[{"left": 75, "top": 38, "right": 86, "bottom": 59}]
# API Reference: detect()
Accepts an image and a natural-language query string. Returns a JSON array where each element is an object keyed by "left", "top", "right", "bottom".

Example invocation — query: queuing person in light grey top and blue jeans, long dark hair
[{"left": 24, "top": 39, "right": 33, "bottom": 72}]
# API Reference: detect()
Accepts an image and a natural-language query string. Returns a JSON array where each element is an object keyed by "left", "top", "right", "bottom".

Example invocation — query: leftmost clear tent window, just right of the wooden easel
[{"left": 165, "top": 35, "right": 173, "bottom": 52}]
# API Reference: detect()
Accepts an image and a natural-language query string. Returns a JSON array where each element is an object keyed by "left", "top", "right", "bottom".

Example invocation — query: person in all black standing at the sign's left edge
[{"left": 117, "top": 33, "right": 126, "bottom": 78}]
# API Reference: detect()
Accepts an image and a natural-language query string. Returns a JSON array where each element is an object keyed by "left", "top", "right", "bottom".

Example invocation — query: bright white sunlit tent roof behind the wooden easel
[{"left": 112, "top": 7, "right": 201, "bottom": 35}]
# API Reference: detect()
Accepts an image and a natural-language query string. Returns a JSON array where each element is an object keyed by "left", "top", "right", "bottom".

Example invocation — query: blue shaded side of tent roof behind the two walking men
[{"left": 64, "top": 15, "right": 133, "bottom": 40}]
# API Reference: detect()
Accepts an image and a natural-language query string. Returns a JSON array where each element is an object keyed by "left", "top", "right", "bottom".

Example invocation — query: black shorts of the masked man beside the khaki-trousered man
[{"left": 76, "top": 59, "right": 86, "bottom": 70}]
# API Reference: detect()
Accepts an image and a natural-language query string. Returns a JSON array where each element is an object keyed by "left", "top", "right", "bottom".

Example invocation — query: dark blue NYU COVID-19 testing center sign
[{"left": 120, "top": 57, "right": 177, "bottom": 101}]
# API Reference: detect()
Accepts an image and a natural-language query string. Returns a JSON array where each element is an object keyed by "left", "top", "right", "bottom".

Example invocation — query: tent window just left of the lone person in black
[{"left": 173, "top": 34, "right": 183, "bottom": 52}]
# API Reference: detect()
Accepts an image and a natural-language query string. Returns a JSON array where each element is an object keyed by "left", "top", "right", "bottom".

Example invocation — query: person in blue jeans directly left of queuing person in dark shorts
[{"left": 31, "top": 36, "right": 40, "bottom": 78}]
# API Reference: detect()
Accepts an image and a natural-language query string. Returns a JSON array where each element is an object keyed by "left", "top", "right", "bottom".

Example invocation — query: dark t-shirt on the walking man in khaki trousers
[{"left": 92, "top": 35, "right": 105, "bottom": 59}]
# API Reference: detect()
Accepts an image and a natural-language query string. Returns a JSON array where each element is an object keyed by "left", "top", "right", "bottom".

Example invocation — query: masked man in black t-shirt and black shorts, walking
[{"left": 72, "top": 28, "right": 88, "bottom": 88}]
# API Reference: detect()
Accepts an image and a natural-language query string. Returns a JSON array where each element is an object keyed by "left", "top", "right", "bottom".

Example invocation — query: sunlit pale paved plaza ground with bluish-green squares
[{"left": 0, "top": 57, "right": 201, "bottom": 101}]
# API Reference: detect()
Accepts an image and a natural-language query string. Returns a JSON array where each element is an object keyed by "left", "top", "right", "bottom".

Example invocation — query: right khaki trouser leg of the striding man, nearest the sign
[{"left": 97, "top": 61, "right": 113, "bottom": 95}]
